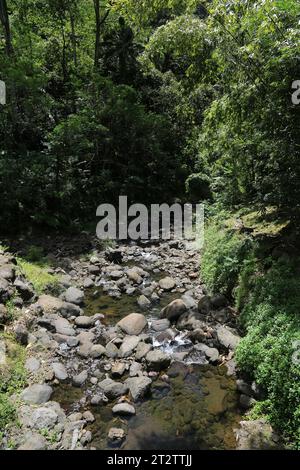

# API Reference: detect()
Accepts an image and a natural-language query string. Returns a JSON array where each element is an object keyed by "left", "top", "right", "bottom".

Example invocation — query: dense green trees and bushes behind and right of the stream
[{"left": 0, "top": 0, "right": 300, "bottom": 448}]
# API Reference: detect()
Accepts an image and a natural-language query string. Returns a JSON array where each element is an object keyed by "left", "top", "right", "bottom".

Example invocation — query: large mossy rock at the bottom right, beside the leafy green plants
[{"left": 235, "top": 419, "right": 280, "bottom": 450}]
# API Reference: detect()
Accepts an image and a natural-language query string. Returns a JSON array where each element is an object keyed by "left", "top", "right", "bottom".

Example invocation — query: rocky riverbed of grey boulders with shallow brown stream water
[{"left": 0, "top": 240, "right": 278, "bottom": 450}]
